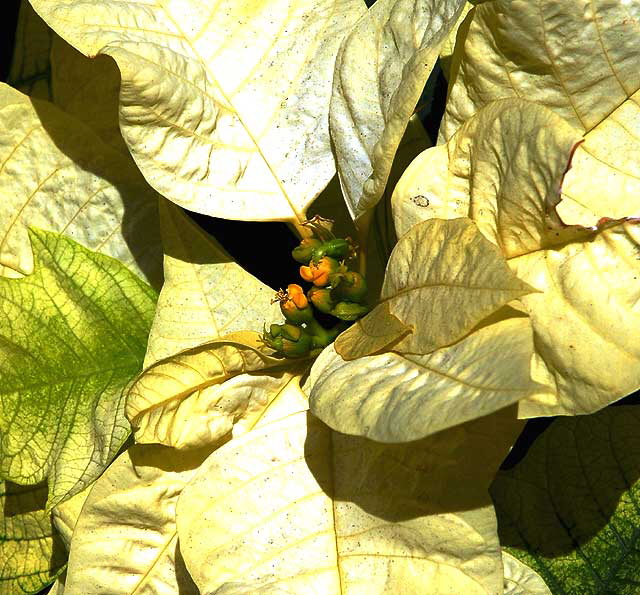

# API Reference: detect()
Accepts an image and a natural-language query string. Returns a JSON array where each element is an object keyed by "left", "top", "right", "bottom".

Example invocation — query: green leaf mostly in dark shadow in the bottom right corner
[{"left": 491, "top": 406, "right": 640, "bottom": 595}]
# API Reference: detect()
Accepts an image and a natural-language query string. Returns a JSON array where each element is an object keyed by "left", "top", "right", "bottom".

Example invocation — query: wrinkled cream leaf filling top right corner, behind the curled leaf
[{"left": 441, "top": 0, "right": 640, "bottom": 225}]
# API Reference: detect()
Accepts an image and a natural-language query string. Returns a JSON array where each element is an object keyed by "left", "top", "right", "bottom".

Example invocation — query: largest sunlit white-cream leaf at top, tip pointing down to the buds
[{"left": 32, "top": 0, "right": 362, "bottom": 220}]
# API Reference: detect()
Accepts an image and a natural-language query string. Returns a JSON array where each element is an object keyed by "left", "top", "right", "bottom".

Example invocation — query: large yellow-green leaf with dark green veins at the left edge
[{"left": 0, "top": 230, "right": 156, "bottom": 508}]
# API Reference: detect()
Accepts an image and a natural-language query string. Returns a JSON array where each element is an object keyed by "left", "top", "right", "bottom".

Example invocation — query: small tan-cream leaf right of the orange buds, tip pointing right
[{"left": 340, "top": 218, "right": 532, "bottom": 359}]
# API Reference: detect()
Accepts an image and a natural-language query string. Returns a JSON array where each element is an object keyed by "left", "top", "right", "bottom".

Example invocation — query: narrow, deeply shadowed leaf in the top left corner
[{"left": 6, "top": 0, "right": 55, "bottom": 101}]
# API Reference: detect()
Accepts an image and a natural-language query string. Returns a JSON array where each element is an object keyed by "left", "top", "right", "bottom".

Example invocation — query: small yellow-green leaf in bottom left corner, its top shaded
[{"left": 0, "top": 481, "right": 66, "bottom": 595}]
